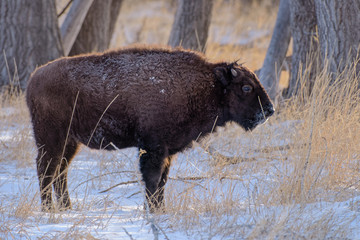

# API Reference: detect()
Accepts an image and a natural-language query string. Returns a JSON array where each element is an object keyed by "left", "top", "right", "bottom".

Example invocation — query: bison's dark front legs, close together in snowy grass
[{"left": 140, "top": 143, "right": 168, "bottom": 212}]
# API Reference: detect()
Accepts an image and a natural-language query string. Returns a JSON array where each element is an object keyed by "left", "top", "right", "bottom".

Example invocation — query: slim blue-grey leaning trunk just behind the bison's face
[{"left": 259, "top": 0, "right": 291, "bottom": 100}]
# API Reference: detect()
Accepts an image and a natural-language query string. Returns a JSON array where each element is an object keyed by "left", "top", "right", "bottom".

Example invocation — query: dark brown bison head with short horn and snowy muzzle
[{"left": 214, "top": 63, "right": 274, "bottom": 131}]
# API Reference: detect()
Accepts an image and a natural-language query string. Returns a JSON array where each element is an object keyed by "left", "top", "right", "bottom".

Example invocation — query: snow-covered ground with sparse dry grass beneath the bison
[{"left": 0, "top": 108, "right": 360, "bottom": 239}]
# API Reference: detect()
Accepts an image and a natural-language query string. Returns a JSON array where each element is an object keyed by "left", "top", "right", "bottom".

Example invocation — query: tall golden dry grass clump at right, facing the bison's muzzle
[{"left": 272, "top": 59, "right": 360, "bottom": 201}]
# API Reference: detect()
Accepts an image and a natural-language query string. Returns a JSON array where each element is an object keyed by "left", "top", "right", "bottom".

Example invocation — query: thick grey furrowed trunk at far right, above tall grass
[{"left": 315, "top": 0, "right": 360, "bottom": 78}]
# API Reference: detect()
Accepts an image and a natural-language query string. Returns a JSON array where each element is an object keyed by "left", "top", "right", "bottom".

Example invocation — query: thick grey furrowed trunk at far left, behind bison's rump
[{"left": 0, "top": 0, "right": 63, "bottom": 89}]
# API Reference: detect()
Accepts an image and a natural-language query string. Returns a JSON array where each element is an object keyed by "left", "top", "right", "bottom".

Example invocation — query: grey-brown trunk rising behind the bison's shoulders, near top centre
[{"left": 168, "top": 0, "right": 213, "bottom": 52}]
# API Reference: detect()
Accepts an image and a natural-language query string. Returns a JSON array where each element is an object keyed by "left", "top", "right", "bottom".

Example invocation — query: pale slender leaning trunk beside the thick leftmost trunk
[{"left": 60, "top": 0, "right": 93, "bottom": 56}]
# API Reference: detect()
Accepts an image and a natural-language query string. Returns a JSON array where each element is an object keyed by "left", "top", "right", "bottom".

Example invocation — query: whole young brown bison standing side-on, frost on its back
[{"left": 26, "top": 47, "right": 274, "bottom": 211}]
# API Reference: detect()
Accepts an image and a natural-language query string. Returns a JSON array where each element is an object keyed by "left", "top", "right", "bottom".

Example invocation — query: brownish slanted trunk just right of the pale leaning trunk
[{"left": 69, "top": 0, "right": 122, "bottom": 55}]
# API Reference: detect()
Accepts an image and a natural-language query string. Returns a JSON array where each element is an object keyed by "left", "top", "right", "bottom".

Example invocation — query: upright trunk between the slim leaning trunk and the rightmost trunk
[{"left": 286, "top": 0, "right": 317, "bottom": 97}]
